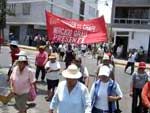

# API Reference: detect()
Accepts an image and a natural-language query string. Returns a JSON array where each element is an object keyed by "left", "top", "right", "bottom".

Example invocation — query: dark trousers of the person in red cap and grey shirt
[{"left": 132, "top": 88, "right": 147, "bottom": 113}]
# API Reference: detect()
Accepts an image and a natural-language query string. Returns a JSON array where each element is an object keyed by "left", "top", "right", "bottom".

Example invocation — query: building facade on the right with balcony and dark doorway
[{"left": 111, "top": 0, "right": 150, "bottom": 57}]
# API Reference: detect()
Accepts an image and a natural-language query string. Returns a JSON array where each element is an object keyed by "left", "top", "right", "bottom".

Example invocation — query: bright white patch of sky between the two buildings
[{"left": 98, "top": 0, "right": 112, "bottom": 23}]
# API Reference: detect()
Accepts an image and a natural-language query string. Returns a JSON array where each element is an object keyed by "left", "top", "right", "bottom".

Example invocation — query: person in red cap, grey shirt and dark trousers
[{"left": 130, "top": 62, "right": 148, "bottom": 113}]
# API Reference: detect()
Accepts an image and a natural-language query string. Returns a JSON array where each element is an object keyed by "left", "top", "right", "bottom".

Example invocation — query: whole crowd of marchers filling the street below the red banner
[{"left": 2, "top": 41, "right": 150, "bottom": 113}]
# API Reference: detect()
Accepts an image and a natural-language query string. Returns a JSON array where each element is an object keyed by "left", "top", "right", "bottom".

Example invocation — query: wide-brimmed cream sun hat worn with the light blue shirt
[{"left": 62, "top": 64, "right": 82, "bottom": 79}]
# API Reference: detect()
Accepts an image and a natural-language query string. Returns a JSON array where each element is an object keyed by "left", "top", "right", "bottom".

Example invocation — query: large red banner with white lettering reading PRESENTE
[{"left": 45, "top": 11, "right": 107, "bottom": 44}]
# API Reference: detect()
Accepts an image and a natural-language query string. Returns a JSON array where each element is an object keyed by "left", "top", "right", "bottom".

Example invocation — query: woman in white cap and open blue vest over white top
[{"left": 90, "top": 66, "right": 123, "bottom": 113}]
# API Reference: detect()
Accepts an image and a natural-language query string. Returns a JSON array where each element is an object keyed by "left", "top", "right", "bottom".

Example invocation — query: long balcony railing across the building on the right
[{"left": 113, "top": 18, "right": 150, "bottom": 25}]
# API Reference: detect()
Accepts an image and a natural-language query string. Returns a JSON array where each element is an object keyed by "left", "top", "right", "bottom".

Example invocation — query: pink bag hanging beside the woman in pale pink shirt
[{"left": 28, "top": 85, "right": 37, "bottom": 101}]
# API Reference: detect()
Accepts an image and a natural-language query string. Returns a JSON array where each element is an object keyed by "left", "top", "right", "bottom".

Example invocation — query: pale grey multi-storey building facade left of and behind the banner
[{"left": 5, "top": 0, "right": 97, "bottom": 44}]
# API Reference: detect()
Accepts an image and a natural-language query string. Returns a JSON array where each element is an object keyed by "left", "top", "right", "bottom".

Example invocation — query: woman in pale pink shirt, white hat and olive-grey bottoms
[{"left": 10, "top": 56, "right": 36, "bottom": 113}]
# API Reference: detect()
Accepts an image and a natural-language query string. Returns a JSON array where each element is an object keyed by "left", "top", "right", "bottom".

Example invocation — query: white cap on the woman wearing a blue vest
[{"left": 98, "top": 66, "right": 110, "bottom": 77}]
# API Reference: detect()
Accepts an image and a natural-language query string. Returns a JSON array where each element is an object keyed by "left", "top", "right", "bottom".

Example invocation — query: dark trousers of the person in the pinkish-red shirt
[{"left": 35, "top": 66, "right": 45, "bottom": 80}]
